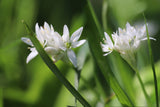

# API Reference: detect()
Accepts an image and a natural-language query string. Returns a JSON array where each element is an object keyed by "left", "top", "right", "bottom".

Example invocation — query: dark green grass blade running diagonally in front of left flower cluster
[{"left": 22, "top": 21, "right": 91, "bottom": 107}]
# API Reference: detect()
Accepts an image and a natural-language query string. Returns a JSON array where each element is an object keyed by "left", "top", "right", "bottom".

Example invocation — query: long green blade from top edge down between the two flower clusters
[{"left": 87, "top": 0, "right": 133, "bottom": 106}]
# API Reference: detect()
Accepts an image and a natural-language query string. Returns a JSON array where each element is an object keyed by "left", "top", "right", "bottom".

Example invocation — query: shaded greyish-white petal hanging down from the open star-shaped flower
[{"left": 67, "top": 49, "right": 77, "bottom": 68}]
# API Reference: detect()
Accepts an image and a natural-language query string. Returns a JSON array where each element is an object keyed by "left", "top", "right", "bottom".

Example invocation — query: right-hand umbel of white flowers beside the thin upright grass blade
[{"left": 101, "top": 22, "right": 155, "bottom": 66}]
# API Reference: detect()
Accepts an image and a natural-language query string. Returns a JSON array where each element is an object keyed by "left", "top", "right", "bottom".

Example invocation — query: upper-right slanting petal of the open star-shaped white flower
[{"left": 70, "top": 27, "right": 83, "bottom": 42}]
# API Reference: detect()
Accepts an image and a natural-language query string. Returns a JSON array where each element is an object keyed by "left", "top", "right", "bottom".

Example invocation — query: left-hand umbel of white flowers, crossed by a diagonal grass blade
[{"left": 21, "top": 22, "right": 86, "bottom": 67}]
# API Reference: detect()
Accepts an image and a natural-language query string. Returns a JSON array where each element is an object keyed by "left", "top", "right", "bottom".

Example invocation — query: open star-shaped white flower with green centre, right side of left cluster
[{"left": 62, "top": 25, "right": 86, "bottom": 67}]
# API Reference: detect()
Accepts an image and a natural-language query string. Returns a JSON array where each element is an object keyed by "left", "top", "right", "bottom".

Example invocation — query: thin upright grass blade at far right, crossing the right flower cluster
[{"left": 143, "top": 14, "right": 159, "bottom": 107}]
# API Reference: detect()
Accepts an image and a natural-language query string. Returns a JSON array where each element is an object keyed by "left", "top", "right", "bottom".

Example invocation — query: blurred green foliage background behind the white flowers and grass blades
[{"left": 0, "top": 0, "right": 160, "bottom": 107}]
